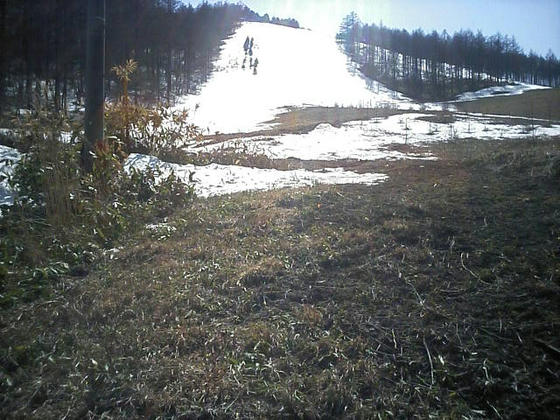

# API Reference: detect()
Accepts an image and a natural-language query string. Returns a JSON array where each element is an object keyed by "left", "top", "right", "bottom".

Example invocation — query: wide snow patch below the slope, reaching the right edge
[{"left": 186, "top": 113, "right": 560, "bottom": 161}]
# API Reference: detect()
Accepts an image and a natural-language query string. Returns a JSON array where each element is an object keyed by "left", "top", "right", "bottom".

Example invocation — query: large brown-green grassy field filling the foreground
[{"left": 0, "top": 135, "right": 560, "bottom": 419}]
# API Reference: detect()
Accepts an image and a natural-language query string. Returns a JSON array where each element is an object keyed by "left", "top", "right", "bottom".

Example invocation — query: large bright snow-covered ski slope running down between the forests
[{"left": 178, "top": 22, "right": 419, "bottom": 134}]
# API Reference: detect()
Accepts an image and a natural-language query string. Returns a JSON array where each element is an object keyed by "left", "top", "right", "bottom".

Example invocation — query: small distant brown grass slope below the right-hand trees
[{"left": 457, "top": 89, "right": 560, "bottom": 121}]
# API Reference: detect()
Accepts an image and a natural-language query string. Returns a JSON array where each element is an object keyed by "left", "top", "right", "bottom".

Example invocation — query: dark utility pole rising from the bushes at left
[{"left": 82, "top": 0, "right": 105, "bottom": 172}]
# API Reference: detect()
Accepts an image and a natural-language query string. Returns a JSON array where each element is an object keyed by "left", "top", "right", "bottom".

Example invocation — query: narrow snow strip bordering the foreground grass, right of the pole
[{"left": 124, "top": 153, "right": 387, "bottom": 197}]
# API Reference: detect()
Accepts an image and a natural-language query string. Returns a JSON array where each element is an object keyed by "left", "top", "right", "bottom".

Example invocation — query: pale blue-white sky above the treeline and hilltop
[{"left": 187, "top": 0, "right": 560, "bottom": 56}]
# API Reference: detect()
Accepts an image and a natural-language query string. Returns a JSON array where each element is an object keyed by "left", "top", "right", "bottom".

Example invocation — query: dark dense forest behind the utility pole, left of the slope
[{"left": 0, "top": 0, "right": 299, "bottom": 111}]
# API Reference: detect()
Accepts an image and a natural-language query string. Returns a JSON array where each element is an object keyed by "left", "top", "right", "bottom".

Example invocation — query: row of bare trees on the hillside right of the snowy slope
[{"left": 337, "top": 13, "right": 560, "bottom": 100}]
